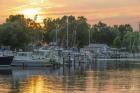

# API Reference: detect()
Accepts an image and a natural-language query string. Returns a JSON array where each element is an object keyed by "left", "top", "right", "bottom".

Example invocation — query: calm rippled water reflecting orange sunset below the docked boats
[{"left": 0, "top": 61, "right": 140, "bottom": 93}]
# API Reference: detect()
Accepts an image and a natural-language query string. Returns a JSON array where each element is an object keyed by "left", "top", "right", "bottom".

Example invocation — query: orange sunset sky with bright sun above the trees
[{"left": 0, "top": 0, "right": 140, "bottom": 30}]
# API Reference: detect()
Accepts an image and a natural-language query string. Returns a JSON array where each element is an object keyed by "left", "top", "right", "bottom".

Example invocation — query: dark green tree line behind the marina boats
[{"left": 0, "top": 15, "right": 139, "bottom": 51}]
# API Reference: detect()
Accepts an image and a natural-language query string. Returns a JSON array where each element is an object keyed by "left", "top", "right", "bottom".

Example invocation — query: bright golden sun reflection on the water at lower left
[{"left": 20, "top": 76, "right": 63, "bottom": 93}]
